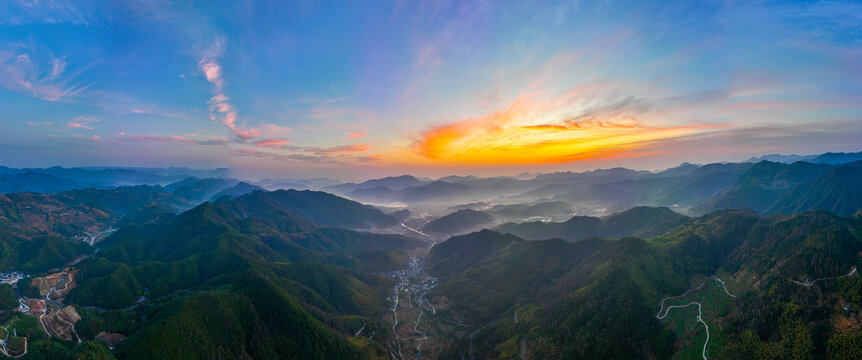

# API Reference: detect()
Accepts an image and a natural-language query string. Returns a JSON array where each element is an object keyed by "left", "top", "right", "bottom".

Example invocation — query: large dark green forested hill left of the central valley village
[{"left": 60, "top": 194, "right": 422, "bottom": 359}]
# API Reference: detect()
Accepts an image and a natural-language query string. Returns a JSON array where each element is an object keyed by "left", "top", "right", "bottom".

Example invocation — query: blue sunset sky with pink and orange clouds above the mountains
[{"left": 0, "top": 0, "right": 862, "bottom": 179}]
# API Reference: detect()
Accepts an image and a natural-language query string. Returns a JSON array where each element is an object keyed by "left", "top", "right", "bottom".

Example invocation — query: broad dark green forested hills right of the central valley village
[{"left": 429, "top": 210, "right": 862, "bottom": 359}]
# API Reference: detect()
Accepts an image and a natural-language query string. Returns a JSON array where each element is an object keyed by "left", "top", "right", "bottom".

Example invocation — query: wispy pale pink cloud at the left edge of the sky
[{"left": 0, "top": 46, "right": 89, "bottom": 101}]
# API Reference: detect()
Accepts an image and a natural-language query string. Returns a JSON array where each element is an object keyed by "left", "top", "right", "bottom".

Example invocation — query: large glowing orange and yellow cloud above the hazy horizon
[{"left": 413, "top": 83, "right": 726, "bottom": 165}]
